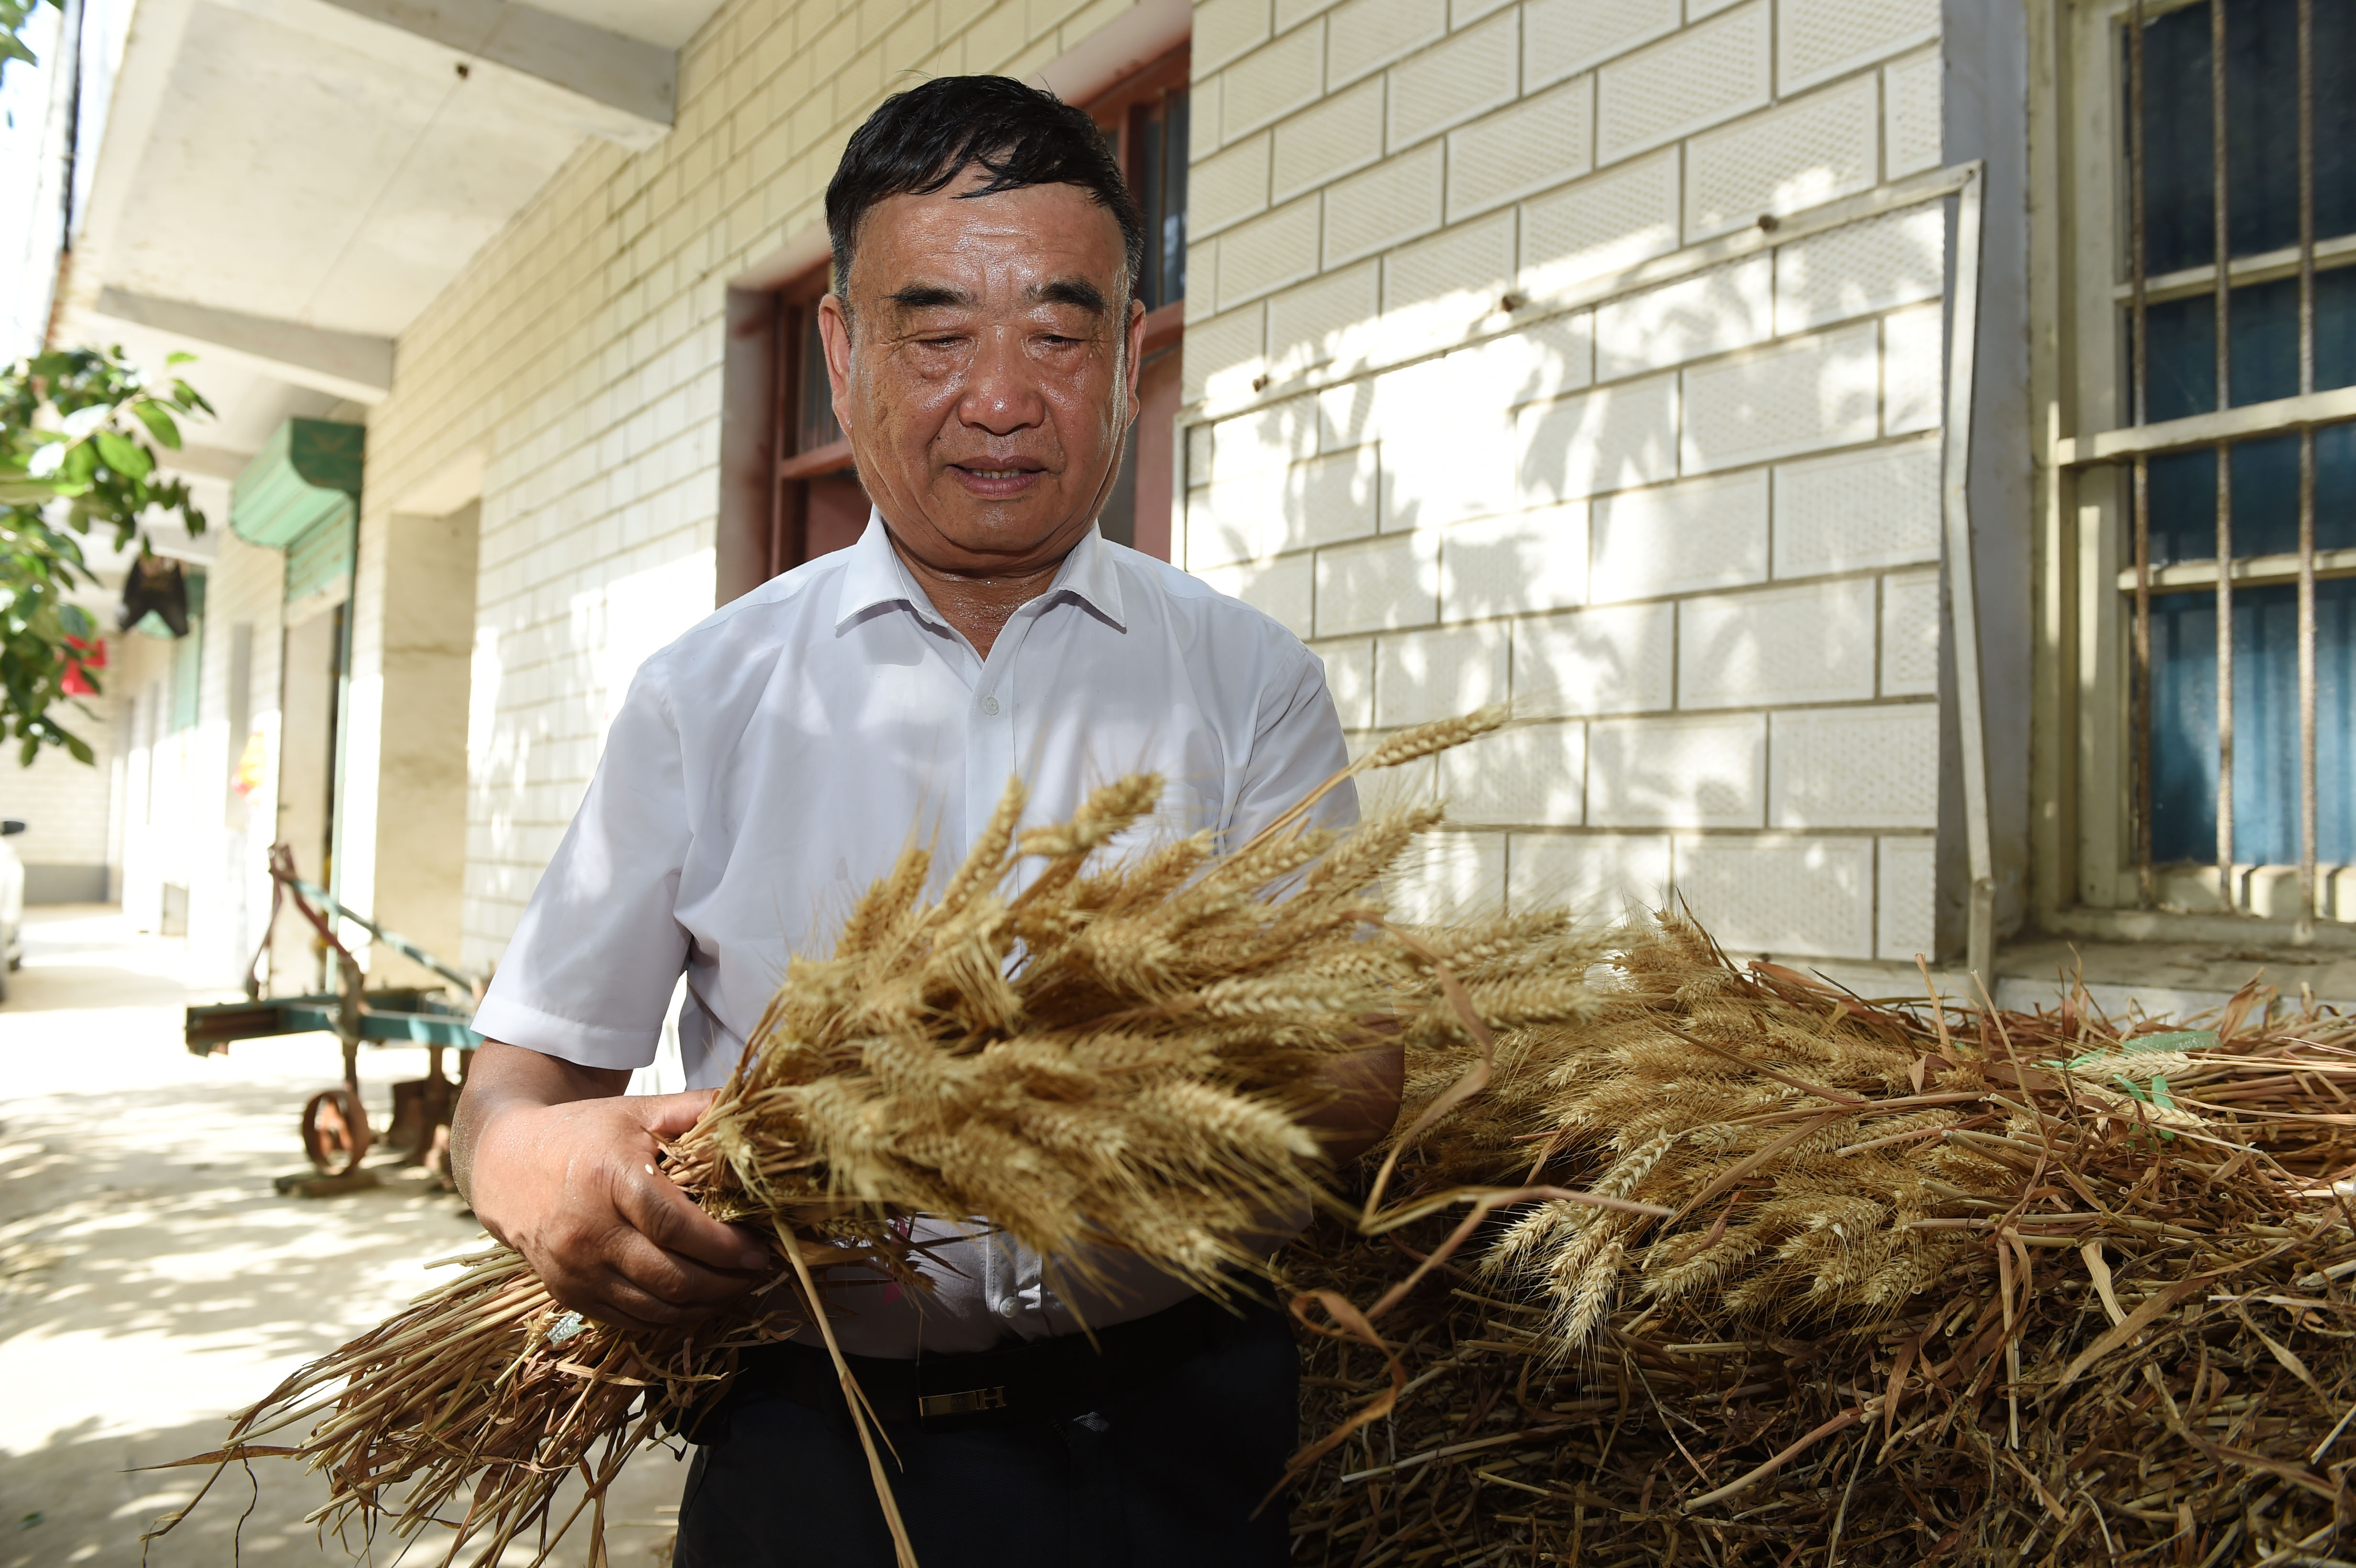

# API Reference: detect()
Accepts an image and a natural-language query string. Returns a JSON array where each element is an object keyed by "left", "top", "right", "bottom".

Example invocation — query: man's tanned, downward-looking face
[{"left": 820, "top": 167, "right": 1145, "bottom": 577}]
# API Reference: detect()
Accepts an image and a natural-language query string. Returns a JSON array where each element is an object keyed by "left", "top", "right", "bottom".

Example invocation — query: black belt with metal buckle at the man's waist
[{"left": 695, "top": 1295, "right": 1239, "bottom": 1441}]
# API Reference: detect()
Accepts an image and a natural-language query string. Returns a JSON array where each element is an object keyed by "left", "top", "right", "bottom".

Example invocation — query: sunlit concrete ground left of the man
[{"left": 0, "top": 909, "right": 686, "bottom": 1568}]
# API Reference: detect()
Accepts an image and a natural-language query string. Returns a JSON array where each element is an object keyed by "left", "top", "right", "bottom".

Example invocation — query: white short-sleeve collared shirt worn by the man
[{"left": 474, "top": 518, "right": 1355, "bottom": 1356}]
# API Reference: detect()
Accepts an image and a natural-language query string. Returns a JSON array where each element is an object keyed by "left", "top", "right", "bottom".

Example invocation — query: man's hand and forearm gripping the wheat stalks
[{"left": 450, "top": 1041, "right": 768, "bottom": 1328}]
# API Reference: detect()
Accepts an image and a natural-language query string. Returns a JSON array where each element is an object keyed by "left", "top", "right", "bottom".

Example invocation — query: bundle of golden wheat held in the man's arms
[{"left": 158, "top": 711, "right": 1630, "bottom": 1563}]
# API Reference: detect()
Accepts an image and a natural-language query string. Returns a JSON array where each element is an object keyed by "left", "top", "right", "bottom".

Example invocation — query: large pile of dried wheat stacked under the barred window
[{"left": 1289, "top": 918, "right": 2356, "bottom": 1568}]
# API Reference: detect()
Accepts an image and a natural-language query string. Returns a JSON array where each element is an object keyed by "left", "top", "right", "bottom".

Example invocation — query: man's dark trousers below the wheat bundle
[{"left": 671, "top": 1307, "right": 1300, "bottom": 1568}]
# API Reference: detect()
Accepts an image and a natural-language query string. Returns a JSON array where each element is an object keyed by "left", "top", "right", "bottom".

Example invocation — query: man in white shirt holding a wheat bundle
[{"left": 452, "top": 78, "right": 1399, "bottom": 1568}]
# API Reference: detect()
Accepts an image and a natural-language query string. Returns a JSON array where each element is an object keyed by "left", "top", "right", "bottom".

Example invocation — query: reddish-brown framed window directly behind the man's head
[{"left": 758, "top": 47, "right": 1188, "bottom": 577}]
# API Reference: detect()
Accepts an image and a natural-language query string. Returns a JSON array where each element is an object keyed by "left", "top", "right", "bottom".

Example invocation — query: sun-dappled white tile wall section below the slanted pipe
[{"left": 1185, "top": 199, "right": 1946, "bottom": 956}]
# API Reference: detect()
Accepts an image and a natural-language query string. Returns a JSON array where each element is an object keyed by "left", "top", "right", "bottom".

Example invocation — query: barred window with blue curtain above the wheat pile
[{"left": 2059, "top": 0, "right": 2356, "bottom": 923}]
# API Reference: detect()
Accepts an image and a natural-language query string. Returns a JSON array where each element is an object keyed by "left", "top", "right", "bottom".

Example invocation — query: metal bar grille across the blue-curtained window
[{"left": 2101, "top": 0, "right": 2351, "bottom": 923}]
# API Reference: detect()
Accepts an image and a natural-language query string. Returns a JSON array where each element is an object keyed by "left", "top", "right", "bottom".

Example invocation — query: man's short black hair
[{"left": 827, "top": 76, "right": 1145, "bottom": 311}]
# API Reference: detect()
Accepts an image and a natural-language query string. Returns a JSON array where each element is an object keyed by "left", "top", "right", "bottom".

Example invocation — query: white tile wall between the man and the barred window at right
[{"left": 1185, "top": 0, "right": 1946, "bottom": 958}]
